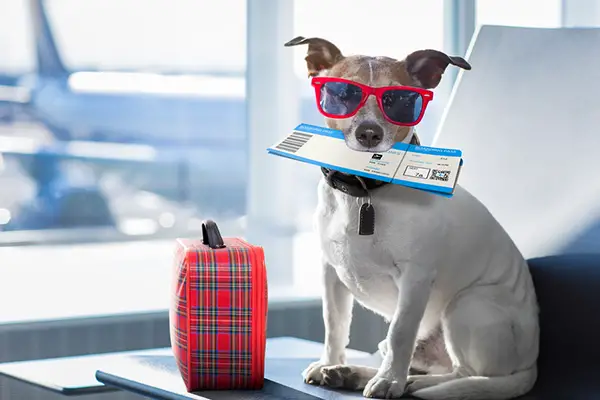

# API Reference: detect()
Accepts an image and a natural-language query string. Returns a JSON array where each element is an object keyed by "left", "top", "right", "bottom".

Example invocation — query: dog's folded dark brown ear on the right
[{"left": 404, "top": 50, "right": 471, "bottom": 89}]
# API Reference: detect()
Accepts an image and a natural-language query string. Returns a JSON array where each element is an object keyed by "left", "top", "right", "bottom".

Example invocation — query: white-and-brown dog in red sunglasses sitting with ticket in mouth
[{"left": 285, "top": 37, "right": 539, "bottom": 400}]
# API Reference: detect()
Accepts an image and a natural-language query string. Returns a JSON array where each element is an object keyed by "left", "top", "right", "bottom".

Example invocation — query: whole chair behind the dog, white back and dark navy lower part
[{"left": 433, "top": 26, "right": 600, "bottom": 400}]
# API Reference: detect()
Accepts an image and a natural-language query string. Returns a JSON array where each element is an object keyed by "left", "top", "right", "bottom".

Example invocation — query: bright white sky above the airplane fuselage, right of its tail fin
[{"left": 46, "top": 0, "right": 246, "bottom": 74}]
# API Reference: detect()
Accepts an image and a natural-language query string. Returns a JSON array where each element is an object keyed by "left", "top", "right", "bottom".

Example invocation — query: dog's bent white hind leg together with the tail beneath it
[{"left": 411, "top": 287, "right": 538, "bottom": 400}]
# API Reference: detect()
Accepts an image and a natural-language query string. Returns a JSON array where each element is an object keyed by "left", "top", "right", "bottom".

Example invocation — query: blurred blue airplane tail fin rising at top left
[{"left": 29, "top": 0, "right": 69, "bottom": 76}]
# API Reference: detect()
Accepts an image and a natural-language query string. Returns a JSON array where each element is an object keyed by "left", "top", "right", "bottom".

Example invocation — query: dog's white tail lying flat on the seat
[{"left": 412, "top": 367, "right": 537, "bottom": 400}]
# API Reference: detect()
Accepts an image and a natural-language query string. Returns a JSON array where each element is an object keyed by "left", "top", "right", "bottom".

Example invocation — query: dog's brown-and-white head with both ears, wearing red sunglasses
[{"left": 285, "top": 36, "right": 471, "bottom": 152}]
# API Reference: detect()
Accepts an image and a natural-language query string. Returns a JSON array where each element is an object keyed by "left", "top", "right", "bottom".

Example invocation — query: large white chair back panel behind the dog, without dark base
[{"left": 434, "top": 26, "right": 600, "bottom": 257}]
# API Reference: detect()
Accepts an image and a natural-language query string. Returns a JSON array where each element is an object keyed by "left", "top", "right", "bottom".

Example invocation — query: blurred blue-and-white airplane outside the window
[{"left": 0, "top": 0, "right": 318, "bottom": 231}]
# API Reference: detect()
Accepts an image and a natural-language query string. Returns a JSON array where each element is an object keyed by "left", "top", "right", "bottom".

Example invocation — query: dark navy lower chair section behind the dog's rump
[{"left": 524, "top": 254, "right": 600, "bottom": 400}]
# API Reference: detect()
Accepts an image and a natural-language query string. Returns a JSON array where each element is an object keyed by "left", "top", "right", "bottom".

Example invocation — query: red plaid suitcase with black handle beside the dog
[{"left": 169, "top": 221, "right": 267, "bottom": 391}]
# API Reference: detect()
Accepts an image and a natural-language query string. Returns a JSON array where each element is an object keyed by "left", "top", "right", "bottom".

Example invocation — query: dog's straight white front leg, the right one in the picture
[{"left": 363, "top": 266, "right": 433, "bottom": 399}]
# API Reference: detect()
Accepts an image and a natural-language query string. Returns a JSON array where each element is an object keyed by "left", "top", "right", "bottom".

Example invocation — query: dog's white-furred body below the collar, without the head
[{"left": 304, "top": 180, "right": 539, "bottom": 400}]
